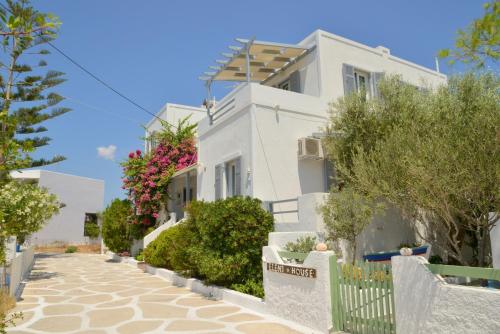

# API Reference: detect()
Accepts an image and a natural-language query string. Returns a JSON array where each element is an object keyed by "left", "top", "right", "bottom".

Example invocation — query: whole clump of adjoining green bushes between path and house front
[{"left": 144, "top": 197, "right": 273, "bottom": 296}]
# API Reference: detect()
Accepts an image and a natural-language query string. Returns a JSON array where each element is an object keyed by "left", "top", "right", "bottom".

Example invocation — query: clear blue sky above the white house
[{"left": 33, "top": 0, "right": 483, "bottom": 203}]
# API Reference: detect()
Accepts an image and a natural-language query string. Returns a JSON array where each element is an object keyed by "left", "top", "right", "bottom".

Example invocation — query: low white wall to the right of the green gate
[{"left": 392, "top": 256, "right": 500, "bottom": 334}]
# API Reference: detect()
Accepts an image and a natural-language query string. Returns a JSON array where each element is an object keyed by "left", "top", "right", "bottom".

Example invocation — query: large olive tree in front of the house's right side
[{"left": 326, "top": 74, "right": 500, "bottom": 266}]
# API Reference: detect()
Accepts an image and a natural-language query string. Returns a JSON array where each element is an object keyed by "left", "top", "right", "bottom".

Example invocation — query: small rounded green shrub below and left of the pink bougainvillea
[{"left": 102, "top": 198, "right": 145, "bottom": 253}]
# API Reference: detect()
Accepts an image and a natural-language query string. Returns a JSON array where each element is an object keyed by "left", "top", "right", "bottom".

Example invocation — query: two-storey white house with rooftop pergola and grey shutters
[{"left": 147, "top": 30, "right": 447, "bottom": 256}]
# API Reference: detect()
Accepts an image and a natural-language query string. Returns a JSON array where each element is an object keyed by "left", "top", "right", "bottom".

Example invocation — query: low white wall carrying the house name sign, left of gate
[{"left": 262, "top": 246, "right": 333, "bottom": 333}]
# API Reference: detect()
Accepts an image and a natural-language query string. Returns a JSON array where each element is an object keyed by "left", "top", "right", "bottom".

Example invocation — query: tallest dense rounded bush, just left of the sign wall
[{"left": 188, "top": 197, "right": 273, "bottom": 287}]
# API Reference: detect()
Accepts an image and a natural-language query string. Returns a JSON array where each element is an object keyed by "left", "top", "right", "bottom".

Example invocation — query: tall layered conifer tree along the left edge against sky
[{"left": 0, "top": 0, "right": 69, "bottom": 181}]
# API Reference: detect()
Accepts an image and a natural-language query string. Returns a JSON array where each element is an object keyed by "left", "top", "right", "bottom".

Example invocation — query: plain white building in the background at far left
[{"left": 11, "top": 170, "right": 104, "bottom": 245}]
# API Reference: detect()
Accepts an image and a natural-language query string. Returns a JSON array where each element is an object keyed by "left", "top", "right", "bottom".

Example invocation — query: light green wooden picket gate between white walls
[{"left": 330, "top": 256, "right": 396, "bottom": 334}]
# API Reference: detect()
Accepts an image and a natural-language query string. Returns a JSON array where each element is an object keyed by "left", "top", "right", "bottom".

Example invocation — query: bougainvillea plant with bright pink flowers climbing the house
[{"left": 122, "top": 118, "right": 197, "bottom": 226}]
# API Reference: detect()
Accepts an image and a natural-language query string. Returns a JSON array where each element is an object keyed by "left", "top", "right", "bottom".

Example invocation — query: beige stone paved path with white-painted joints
[{"left": 8, "top": 254, "right": 308, "bottom": 334}]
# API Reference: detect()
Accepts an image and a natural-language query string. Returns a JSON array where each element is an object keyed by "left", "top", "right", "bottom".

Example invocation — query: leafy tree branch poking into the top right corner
[{"left": 438, "top": 0, "right": 500, "bottom": 68}]
